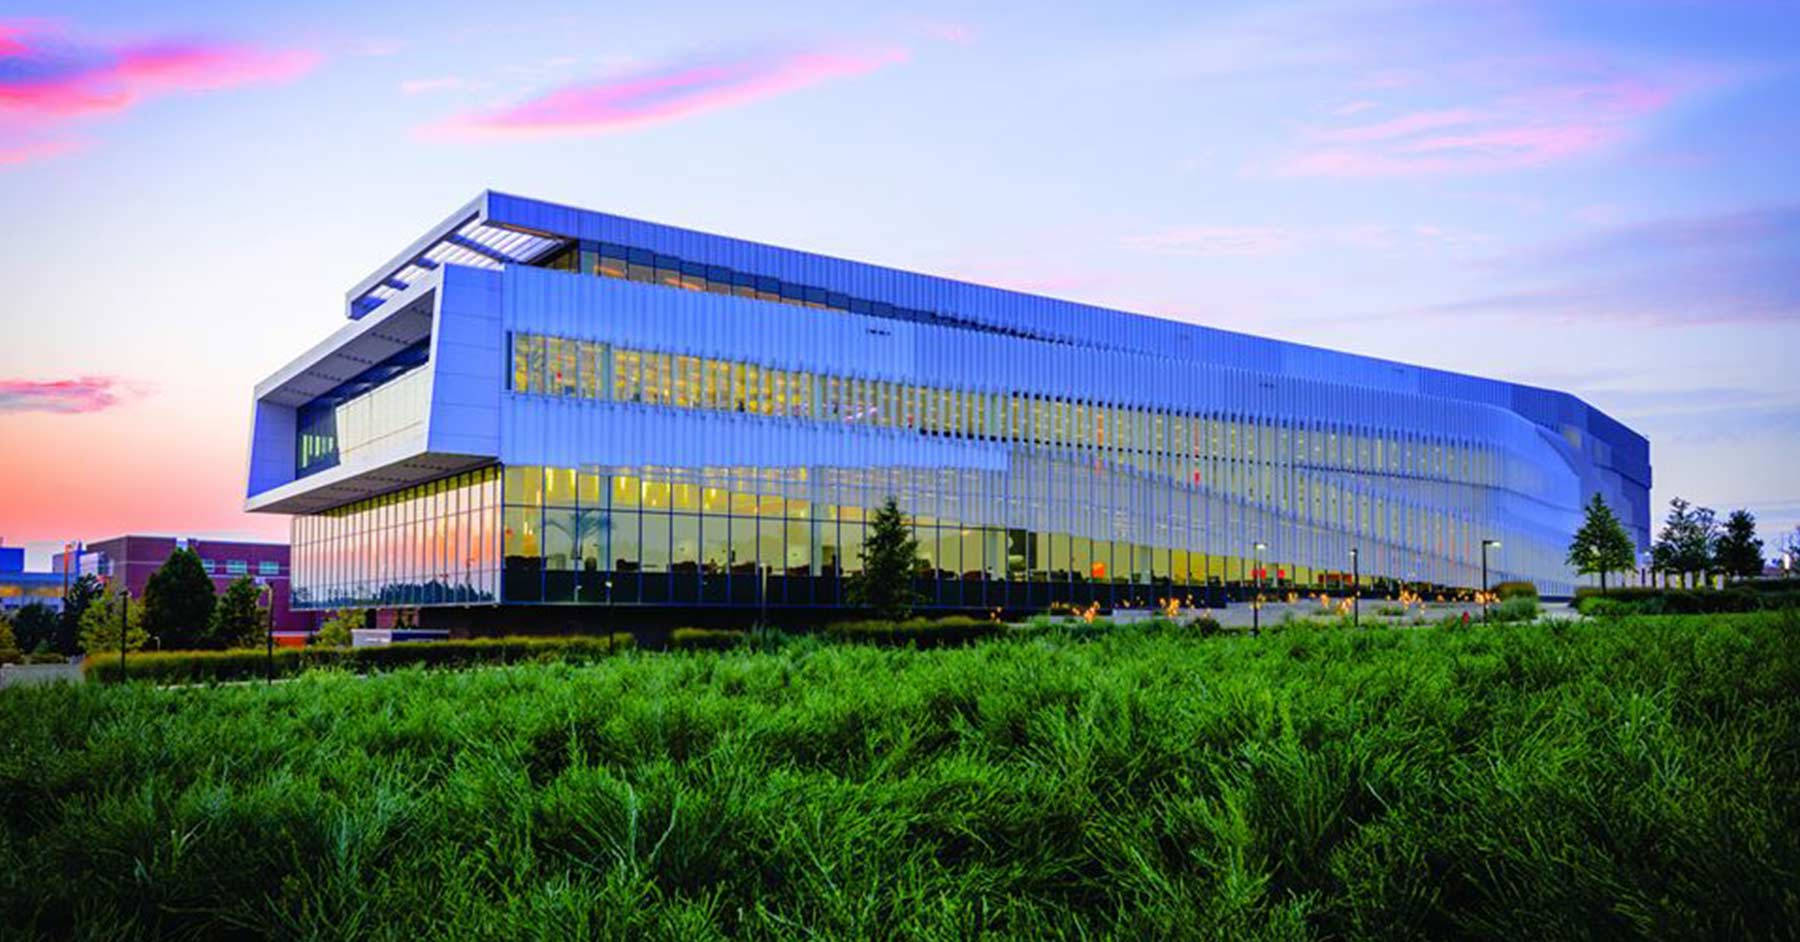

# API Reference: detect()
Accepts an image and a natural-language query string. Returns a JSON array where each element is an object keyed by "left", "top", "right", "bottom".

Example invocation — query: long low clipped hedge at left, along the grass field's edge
[{"left": 81, "top": 632, "right": 634, "bottom": 684}]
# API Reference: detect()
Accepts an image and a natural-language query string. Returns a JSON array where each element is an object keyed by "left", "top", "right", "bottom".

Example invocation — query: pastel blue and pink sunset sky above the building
[{"left": 0, "top": 0, "right": 1800, "bottom": 567}]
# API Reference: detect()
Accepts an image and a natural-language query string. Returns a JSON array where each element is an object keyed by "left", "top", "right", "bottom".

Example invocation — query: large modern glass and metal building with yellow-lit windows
[{"left": 247, "top": 193, "right": 1651, "bottom": 625}]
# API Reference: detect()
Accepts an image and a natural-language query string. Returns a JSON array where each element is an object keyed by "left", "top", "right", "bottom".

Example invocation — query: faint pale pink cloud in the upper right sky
[{"left": 1276, "top": 79, "right": 1678, "bottom": 177}]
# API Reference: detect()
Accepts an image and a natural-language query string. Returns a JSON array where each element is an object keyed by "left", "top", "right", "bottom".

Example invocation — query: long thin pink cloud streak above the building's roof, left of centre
[{"left": 423, "top": 49, "right": 907, "bottom": 137}]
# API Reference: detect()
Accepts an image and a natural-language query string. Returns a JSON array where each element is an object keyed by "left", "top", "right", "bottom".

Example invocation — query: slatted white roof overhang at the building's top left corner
[{"left": 344, "top": 193, "right": 571, "bottom": 321}]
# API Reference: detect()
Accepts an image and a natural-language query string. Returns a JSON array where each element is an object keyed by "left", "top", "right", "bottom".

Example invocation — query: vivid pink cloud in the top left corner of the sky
[{"left": 0, "top": 23, "right": 320, "bottom": 164}]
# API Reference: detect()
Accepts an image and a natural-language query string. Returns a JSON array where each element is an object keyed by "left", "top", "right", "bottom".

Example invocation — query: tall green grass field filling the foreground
[{"left": 0, "top": 612, "right": 1800, "bottom": 940}]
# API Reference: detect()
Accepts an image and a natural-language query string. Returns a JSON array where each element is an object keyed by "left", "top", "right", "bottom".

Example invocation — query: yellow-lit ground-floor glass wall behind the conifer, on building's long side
[{"left": 502, "top": 465, "right": 1252, "bottom": 609}]
